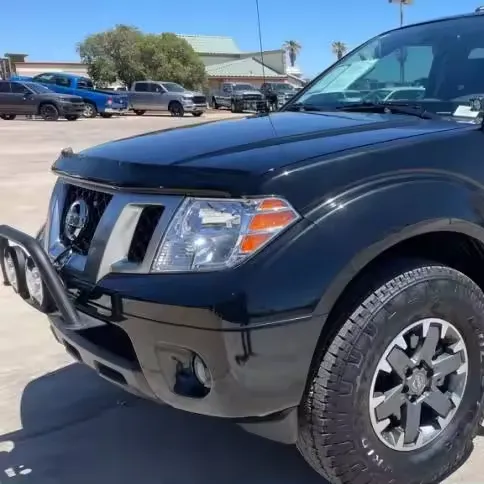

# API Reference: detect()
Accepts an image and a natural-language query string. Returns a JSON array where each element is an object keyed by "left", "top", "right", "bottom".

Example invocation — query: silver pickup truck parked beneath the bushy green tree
[{"left": 128, "top": 81, "right": 207, "bottom": 116}]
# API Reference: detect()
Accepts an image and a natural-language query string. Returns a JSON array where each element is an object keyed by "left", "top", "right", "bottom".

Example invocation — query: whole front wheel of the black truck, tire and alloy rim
[{"left": 298, "top": 263, "right": 484, "bottom": 484}]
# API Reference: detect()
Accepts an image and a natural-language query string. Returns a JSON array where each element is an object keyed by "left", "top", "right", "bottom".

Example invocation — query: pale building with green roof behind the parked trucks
[{"left": 178, "top": 34, "right": 303, "bottom": 89}]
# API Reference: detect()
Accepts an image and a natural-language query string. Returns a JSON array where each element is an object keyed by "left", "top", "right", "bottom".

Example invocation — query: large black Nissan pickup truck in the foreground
[{"left": 4, "top": 9, "right": 484, "bottom": 484}]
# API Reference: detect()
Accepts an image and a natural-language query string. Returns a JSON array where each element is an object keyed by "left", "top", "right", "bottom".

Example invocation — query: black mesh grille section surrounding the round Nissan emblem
[{"left": 59, "top": 185, "right": 112, "bottom": 255}]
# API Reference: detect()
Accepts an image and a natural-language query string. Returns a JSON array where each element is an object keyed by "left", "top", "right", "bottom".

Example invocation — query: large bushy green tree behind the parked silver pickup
[{"left": 77, "top": 25, "right": 206, "bottom": 89}]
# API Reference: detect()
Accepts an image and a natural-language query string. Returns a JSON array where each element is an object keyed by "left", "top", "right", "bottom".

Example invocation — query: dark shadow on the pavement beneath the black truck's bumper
[{"left": 0, "top": 364, "right": 325, "bottom": 484}]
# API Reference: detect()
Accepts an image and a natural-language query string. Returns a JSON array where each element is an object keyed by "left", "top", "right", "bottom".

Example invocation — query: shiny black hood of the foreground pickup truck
[{"left": 53, "top": 112, "right": 464, "bottom": 194}]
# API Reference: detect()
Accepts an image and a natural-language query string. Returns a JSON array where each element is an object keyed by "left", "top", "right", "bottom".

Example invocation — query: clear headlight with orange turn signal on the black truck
[{"left": 151, "top": 197, "right": 300, "bottom": 272}]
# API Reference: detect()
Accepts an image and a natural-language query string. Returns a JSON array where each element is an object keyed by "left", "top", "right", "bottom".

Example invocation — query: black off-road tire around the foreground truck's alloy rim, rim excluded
[{"left": 297, "top": 261, "right": 484, "bottom": 484}]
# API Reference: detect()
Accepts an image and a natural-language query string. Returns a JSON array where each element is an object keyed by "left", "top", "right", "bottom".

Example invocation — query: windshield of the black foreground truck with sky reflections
[{"left": 284, "top": 15, "right": 484, "bottom": 112}]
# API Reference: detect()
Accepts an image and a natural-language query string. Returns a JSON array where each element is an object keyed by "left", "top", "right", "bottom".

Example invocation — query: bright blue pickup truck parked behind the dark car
[{"left": 12, "top": 72, "right": 128, "bottom": 118}]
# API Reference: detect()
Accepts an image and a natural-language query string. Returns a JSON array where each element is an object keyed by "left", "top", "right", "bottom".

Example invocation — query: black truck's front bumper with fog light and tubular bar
[{"left": 0, "top": 226, "right": 318, "bottom": 441}]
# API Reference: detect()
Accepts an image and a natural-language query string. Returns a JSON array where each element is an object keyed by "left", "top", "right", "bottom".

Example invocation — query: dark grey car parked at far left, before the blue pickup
[{"left": 0, "top": 81, "right": 84, "bottom": 121}]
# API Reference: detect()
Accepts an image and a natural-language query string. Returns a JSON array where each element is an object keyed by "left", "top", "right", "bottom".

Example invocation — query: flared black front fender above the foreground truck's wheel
[{"left": 307, "top": 174, "right": 484, "bottom": 315}]
